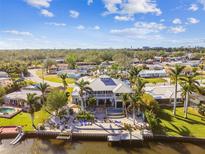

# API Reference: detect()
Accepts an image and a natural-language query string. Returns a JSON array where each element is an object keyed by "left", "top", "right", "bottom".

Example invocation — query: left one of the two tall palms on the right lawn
[{"left": 170, "top": 64, "right": 185, "bottom": 115}]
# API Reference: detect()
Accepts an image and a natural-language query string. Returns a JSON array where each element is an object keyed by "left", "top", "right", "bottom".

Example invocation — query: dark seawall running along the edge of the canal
[{"left": 0, "top": 132, "right": 205, "bottom": 143}]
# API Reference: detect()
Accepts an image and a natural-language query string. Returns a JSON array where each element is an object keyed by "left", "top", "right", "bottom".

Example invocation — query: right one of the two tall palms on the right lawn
[{"left": 180, "top": 73, "right": 200, "bottom": 118}]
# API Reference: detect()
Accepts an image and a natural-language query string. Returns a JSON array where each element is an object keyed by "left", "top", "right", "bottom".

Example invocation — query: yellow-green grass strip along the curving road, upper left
[{"left": 36, "top": 70, "right": 75, "bottom": 84}]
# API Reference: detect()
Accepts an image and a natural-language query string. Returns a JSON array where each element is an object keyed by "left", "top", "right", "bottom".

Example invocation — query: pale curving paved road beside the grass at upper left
[{"left": 27, "top": 69, "right": 63, "bottom": 87}]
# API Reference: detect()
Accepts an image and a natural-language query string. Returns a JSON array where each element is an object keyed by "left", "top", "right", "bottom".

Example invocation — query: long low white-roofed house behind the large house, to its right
[{"left": 139, "top": 69, "right": 167, "bottom": 78}]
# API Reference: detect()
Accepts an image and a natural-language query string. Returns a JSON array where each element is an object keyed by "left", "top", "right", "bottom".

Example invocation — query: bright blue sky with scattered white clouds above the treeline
[{"left": 0, "top": 0, "right": 205, "bottom": 49}]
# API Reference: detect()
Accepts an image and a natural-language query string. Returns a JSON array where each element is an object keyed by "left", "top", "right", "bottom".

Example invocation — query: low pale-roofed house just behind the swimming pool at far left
[{"left": 4, "top": 86, "right": 42, "bottom": 108}]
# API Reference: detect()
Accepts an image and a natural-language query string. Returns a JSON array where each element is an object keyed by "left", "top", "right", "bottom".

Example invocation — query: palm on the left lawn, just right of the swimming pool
[{"left": 25, "top": 93, "right": 42, "bottom": 129}]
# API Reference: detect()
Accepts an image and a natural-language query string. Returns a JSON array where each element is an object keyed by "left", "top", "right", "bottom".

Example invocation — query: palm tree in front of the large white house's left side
[{"left": 75, "top": 79, "right": 92, "bottom": 111}]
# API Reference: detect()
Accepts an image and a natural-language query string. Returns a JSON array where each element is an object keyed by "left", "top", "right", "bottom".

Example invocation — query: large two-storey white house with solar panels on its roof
[{"left": 72, "top": 75, "right": 132, "bottom": 108}]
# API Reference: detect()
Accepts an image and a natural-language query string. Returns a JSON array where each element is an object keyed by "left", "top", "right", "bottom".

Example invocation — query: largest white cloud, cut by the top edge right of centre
[{"left": 103, "top": 0, "right": 162, "bottom": 15}]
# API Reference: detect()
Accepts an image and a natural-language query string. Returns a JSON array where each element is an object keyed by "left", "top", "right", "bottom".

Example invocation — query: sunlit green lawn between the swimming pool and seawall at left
[{"left": 0, "top": 109, "right": 49, "bottom": 131}]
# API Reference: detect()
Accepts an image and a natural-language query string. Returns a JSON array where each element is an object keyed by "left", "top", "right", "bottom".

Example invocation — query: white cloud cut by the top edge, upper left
[{"left": 25, "top": 0, "right": 52, "bottom": 8}]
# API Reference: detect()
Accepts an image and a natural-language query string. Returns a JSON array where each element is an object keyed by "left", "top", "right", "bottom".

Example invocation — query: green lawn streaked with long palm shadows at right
[{"left": 155, "top": 108, "right": 205, "bottom": 137}]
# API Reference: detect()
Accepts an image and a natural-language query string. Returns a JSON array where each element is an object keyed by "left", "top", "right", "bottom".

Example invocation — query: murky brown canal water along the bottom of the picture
[{"left": 0, "top": 139, "right": 205, "bottom": 154}]
